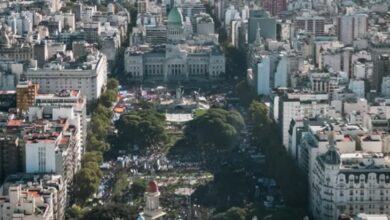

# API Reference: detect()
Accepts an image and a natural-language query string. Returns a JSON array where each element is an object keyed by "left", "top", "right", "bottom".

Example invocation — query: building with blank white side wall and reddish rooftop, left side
[{"left": 23, "top": 118, "right": 80, "bottom": 191}]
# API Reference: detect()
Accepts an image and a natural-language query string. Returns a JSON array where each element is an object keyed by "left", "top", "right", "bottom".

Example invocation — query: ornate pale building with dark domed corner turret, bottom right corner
[{"left": 310, "top": 148, "right": 390, "bottom": 220}]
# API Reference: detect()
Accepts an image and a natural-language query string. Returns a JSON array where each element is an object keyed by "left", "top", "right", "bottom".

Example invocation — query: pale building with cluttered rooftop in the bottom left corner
[{"left": 0, "top": 173, "right": 67, "bottom": 220}]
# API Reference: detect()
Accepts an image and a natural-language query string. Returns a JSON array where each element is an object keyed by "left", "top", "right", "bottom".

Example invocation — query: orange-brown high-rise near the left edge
[{"left": 16, "top": 81, "right": 39, "bottom": 112}]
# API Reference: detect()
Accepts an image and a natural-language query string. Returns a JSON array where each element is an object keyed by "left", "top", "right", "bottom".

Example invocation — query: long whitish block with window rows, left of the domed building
[{"left": 26, "top": 51, "right": 107, "bottom": 102}]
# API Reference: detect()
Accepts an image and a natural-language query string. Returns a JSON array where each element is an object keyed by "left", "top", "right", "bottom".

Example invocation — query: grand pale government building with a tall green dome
[{"left": 124, "top": 5, "right": 225, "bottom": 82}]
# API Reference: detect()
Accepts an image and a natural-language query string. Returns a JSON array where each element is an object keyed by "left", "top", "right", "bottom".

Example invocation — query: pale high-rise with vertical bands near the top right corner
[{"left": 337, "top": 14, "right": 368, "bottom": 44}]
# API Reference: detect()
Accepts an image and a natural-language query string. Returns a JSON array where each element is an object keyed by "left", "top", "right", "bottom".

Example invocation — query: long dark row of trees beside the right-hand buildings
[{"left": 249, "top": 101, "right": 307, "bottom": 219}]
